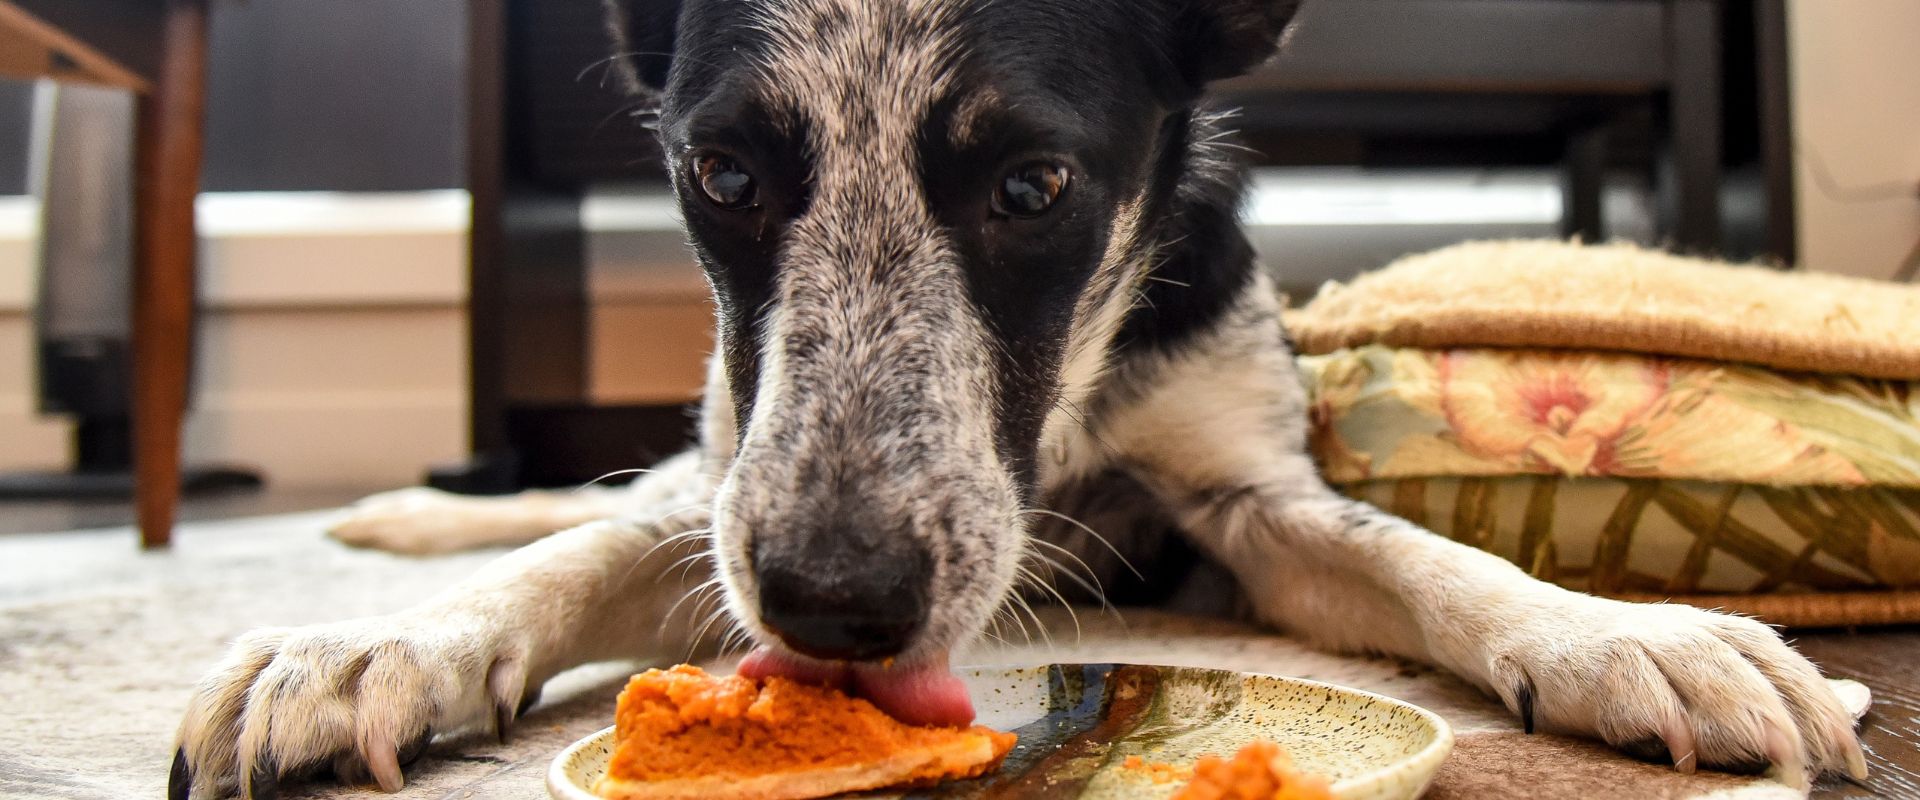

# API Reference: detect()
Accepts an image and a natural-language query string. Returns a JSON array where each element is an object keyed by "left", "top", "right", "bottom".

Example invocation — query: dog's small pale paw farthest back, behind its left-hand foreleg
[{"left": 326, "top": 487, "right": 501, "bottom": 556}]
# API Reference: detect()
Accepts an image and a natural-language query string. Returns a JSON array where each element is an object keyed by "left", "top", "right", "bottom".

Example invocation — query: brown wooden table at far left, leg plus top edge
[{"left": 0, "top": 0, "right": 220, "bottom": 547}]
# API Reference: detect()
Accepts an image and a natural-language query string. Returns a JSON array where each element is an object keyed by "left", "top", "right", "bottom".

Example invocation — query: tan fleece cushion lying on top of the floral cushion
[{"left": 1286, "top": 240, "right": 1920, "bottom": 380}]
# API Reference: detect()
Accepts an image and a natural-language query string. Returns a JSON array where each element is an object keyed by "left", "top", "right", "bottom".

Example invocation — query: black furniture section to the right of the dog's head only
[{"left": 1217, "top": 0, "right": 1793, "bottom": 263}]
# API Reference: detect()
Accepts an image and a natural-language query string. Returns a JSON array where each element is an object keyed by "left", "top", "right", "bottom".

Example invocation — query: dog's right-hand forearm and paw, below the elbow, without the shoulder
[{"left": 1144, "top": 448, "right": 1866, "bottom": 787}]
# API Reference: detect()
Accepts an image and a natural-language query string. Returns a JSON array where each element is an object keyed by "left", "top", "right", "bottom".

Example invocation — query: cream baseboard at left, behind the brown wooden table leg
[{"left": 0, "top": 192, "right": 468, "bottom": 487}]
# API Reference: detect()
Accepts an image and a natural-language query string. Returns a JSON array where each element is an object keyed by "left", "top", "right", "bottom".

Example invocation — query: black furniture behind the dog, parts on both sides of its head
[{"left": 445, "top": 0, "right": 1793, "bottom": 491}]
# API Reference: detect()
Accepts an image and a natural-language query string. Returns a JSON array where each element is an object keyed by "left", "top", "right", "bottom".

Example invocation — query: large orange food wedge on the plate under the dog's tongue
[{"left": 607, "top": 664, "right": 1016, "bottom": 785}]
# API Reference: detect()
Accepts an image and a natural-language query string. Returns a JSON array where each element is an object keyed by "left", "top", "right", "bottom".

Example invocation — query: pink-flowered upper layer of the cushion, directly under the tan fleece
[{"left": 1300, "top": 345, "right": 1920, "bottom": 487}]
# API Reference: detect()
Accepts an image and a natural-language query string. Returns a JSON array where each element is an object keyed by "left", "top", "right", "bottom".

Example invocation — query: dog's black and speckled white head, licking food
[{"left": 609, "top": 0, "right": 1298, "bottom": 717}]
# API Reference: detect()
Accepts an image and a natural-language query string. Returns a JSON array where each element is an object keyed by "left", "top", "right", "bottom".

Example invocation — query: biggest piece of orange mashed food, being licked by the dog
[{"left": 593, "top": 664, "right": 1016, "bottom": 800}]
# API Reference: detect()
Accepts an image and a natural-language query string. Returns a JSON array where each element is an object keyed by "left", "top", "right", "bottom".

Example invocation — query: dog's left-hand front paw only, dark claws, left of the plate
[{"left": 167, "top": 612, "right": 528, "bottom": 800}]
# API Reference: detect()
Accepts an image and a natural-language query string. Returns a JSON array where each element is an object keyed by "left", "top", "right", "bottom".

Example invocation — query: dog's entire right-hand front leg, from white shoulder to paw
[{"left": 1100, "top": 287, "right": 1866, "bottom": 787}]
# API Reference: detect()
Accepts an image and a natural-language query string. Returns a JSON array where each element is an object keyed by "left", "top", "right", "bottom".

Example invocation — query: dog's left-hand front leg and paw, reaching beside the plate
[{"left": 169, "top": 470, "right": 710, "bottom": 800}]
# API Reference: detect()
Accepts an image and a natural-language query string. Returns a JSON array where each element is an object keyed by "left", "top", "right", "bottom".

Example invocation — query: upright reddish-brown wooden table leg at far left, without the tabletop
[{"left": 132, "top": 0, "right": 207, "bottom": 547}]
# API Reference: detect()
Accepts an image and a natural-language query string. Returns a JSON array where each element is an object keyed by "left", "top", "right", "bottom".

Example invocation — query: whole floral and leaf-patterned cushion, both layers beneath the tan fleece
[{"left": 1300, "top": 345, "right": 1920, "bottom": 606}]
